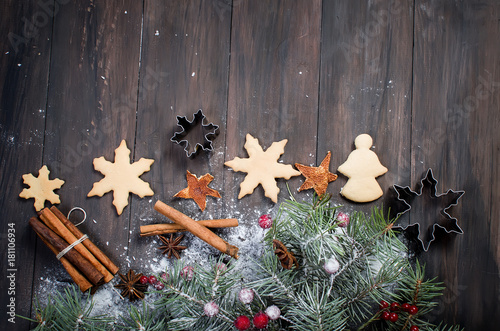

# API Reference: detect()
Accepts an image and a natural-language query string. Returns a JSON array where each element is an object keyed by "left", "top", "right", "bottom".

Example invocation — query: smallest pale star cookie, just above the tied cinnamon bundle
[{"left": 19, "top": 165, "right": 64, "bottom": 211}]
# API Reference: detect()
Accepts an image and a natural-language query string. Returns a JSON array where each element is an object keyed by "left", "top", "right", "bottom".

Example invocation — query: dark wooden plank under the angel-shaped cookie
[{"left": 318, "top": 0, "right": 413, "bottom": 212}]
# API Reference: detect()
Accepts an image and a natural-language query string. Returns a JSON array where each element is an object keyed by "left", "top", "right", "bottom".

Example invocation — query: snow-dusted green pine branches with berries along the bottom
[{"left": 22, "top": 196, "right": 460, "bottom": 331}]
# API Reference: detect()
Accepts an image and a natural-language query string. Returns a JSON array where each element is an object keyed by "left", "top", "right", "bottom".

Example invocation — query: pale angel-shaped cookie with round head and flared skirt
[{"left": 337, "top": 134, "right": 387, "bottom": 202}]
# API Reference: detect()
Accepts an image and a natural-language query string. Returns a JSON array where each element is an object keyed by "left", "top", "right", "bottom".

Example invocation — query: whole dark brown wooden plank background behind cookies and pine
[{"left": 0, "top": 0, "right": 500, "bottom": 330}]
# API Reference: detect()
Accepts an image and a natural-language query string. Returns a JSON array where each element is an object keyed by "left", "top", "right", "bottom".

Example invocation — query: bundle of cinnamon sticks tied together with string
[{"left": 29, "top": 206, "right": 118, "bottom": 292}]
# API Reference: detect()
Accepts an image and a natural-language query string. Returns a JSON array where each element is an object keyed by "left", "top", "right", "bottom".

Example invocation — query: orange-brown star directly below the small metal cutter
[{"left": 174, "top": 170, "right": 221, "bottom": 211}]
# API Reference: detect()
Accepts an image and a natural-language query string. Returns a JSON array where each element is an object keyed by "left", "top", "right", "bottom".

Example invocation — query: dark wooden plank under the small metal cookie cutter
[{"left": 130, "top": 0, "right": 231, "bottom": 270}]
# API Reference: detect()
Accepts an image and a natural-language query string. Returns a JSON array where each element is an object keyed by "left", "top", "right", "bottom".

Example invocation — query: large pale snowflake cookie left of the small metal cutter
[{"left": 87, "top": 140, "right": 154, "bottom": 215}]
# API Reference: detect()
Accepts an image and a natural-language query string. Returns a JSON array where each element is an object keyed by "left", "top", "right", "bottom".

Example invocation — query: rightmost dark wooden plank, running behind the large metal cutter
[{"left": 412, "top": 1, "right": 500, "bottom": 330}]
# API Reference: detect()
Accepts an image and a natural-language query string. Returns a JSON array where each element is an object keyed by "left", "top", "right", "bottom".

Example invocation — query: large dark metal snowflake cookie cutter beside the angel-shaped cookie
[{"left": 393, "top": 168, "right": 465, "bottom": 252}]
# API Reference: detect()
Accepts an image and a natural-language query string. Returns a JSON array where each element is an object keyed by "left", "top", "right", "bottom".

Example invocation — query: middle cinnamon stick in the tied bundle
[{"left": 39, "top": 208, "right": 114, "bottom": 283}]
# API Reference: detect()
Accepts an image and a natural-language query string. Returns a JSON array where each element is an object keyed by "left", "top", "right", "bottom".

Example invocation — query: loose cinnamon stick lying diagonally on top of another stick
[{"left": 154, "top": 201, "right": 238, "bottom": 259}]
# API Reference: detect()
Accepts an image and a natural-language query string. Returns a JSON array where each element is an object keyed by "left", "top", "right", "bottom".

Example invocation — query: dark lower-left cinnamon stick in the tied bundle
[{"left": 29, "top": 217, "right": 104, "bottom": 285}]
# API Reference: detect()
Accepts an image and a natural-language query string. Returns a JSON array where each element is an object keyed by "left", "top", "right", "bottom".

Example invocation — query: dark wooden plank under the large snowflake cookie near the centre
[{"left": 224, "top": 0, "right": 324, "bottom": 213}]
